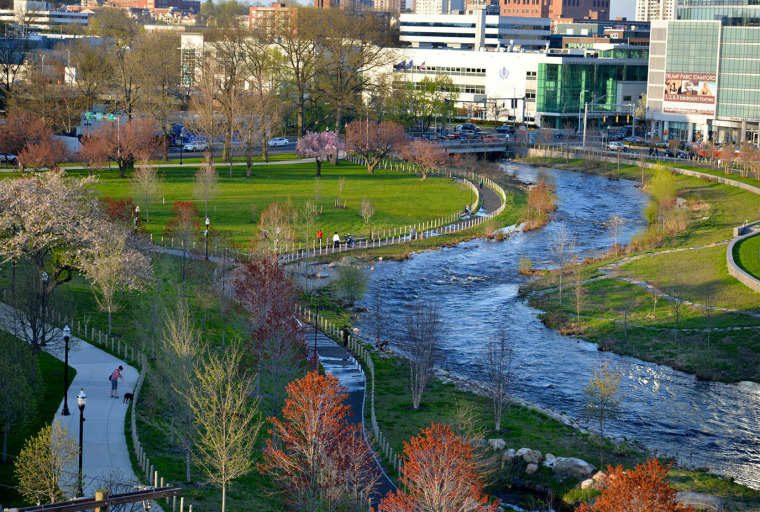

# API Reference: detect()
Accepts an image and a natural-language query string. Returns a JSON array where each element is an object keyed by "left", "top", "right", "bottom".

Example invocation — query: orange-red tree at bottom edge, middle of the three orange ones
[{"left": 378, "top": 423, "right": 500, "bottom": 512}]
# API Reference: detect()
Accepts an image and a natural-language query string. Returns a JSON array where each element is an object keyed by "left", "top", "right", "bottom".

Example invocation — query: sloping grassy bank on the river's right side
[{"left": 526, "top": 159, "right": 760, "bottom": 382}]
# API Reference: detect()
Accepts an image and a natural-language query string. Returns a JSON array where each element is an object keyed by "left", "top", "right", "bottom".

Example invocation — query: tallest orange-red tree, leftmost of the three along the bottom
[{"left": 261, "top": 372, "right": 380, "bottom": 510}]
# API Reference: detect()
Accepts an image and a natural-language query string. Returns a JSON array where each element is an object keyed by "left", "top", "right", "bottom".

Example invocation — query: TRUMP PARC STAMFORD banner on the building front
[{"left": 662, "top": 73, "right": 718, "bottom": 116}]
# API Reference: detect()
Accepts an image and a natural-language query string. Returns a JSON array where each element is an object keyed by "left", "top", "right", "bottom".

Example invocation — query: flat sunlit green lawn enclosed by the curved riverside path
[{"left": 58, "top": 161, "right": 469, "bottom": 248}]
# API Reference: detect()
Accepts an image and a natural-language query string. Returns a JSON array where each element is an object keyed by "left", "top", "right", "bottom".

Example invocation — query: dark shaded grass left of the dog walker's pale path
[{"left": 0, "top": 352, "right": 77, "bottom": 507}]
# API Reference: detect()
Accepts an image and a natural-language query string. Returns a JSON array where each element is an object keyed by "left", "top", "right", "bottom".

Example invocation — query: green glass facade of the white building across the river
[{"left": 536, "top": 59, "right": 647, "bottom": 127}]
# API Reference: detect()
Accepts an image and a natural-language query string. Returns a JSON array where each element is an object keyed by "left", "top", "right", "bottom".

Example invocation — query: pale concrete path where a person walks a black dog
[{"left": 0, "top": 304, "right": 138, "bottom": 496}]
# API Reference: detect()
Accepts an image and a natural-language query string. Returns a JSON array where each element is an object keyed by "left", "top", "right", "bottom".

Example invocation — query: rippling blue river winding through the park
[{"left": 357, "top": 164, "right": 760, "bottom": 489}]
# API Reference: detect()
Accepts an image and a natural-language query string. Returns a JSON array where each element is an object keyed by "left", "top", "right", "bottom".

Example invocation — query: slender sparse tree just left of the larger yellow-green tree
[{"left": 156, "top": 298, "right": 203, "bottom": 482}]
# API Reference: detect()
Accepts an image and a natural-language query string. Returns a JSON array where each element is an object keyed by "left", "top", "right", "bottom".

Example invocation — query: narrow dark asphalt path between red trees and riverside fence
[{"left": 306, "top": 325, "right": 396, "bottom": 506}]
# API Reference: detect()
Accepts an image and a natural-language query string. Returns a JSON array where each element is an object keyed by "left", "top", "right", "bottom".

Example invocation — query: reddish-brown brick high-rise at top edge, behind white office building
[{"left": 500, "top": 0, "right": 610, "bottom": 21}]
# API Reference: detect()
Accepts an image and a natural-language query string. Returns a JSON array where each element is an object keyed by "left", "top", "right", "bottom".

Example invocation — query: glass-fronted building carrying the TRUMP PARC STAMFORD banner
[{"left": 647, "top": 0, "right": 760, "bottom": 144}]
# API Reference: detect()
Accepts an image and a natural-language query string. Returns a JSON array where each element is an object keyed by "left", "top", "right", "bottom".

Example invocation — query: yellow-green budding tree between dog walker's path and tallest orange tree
[{"left": 177, "top": 347, "right": 261, "bottom": 512}]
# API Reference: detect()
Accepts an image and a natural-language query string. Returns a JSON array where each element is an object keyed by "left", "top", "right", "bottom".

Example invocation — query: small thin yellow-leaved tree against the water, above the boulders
[{"left": 583, "top": 362, "right": 623, "bottom": 464}]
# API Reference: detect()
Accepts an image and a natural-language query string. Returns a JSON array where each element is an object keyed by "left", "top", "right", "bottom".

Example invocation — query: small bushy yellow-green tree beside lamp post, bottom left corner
[{"left": 15, "top": 421, "right": 79, "bottom": 503}]
